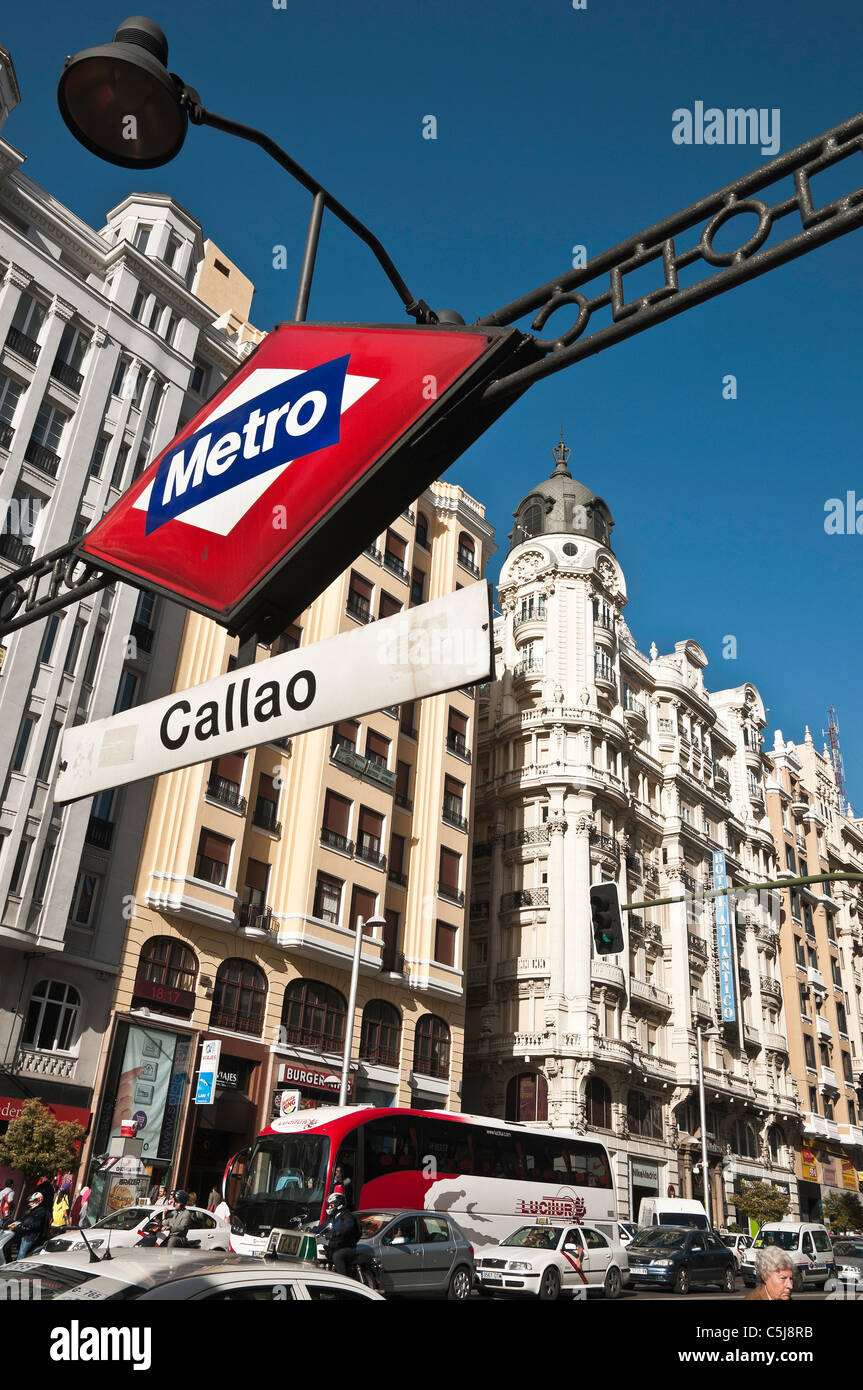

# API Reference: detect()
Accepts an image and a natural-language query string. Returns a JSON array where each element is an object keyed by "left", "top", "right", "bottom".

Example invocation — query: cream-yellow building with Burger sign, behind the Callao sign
[{"left": 84, "top": 482, "right": 493, "bottom": 1193}]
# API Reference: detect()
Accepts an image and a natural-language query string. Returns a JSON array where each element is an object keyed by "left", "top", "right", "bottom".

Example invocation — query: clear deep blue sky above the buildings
[{"left": 6, "top": 0, "right": 863, "bottom": 812}]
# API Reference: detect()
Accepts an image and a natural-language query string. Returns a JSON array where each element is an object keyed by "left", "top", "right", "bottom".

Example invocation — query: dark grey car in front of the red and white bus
[{"left": 357, "top": 1211, "right": 477, "bottom": 1300}]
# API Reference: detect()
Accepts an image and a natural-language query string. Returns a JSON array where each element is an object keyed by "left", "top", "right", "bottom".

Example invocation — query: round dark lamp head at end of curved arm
[{"left": 57, "top": 15, "right": 189, "bottom": 170}]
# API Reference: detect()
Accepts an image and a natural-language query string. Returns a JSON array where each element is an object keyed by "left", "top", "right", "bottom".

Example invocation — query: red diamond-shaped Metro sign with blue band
[{"left": 78, "top": 324, "right": 534, "bottom": 638}]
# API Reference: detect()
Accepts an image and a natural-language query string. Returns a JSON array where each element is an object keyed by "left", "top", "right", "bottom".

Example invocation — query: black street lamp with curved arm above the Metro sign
[{"left": 57, "top": 15, "right": 436, "bottom": 324}]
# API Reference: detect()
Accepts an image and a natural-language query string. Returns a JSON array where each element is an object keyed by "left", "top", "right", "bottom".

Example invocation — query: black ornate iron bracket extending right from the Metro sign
[{"left": 477, "top": 102, "right": 863, "bottom": 399}]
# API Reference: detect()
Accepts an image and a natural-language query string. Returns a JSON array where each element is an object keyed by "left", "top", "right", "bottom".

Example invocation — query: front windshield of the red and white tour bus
[{"left": 235, "top": 1134, "right": 329, "bottom": 1227}]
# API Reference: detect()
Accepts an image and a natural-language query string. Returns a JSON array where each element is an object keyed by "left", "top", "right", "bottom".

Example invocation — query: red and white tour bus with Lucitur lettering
[{"left": 224, "top": 1105, "right": 617, "bottom": 1255}]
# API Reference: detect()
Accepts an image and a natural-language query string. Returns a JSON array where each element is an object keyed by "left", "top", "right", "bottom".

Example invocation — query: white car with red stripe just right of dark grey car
[{"left": 477, "top": 1222, "right": 630, "bottom": 1302}]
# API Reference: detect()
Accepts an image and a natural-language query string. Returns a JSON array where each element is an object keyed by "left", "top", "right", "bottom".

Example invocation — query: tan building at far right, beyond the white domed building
[{"left": 766, "top": 730, "right": 863, "bottom": 1220}]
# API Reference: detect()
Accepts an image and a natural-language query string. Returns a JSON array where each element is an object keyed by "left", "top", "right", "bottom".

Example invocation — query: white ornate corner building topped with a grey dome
[{"left": 463, "top": 438, "right": 802, "bottom": 1227}]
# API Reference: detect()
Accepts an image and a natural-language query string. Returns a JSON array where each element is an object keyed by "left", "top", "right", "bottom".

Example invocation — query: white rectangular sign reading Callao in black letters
[{"left": 54, "top": 581, "right": 493, "bottom": 802}]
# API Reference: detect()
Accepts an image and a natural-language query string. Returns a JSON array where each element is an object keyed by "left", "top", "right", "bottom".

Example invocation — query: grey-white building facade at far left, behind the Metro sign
[{"left": 0, "top": 40, "right": 261, "bottom": 1150}]
